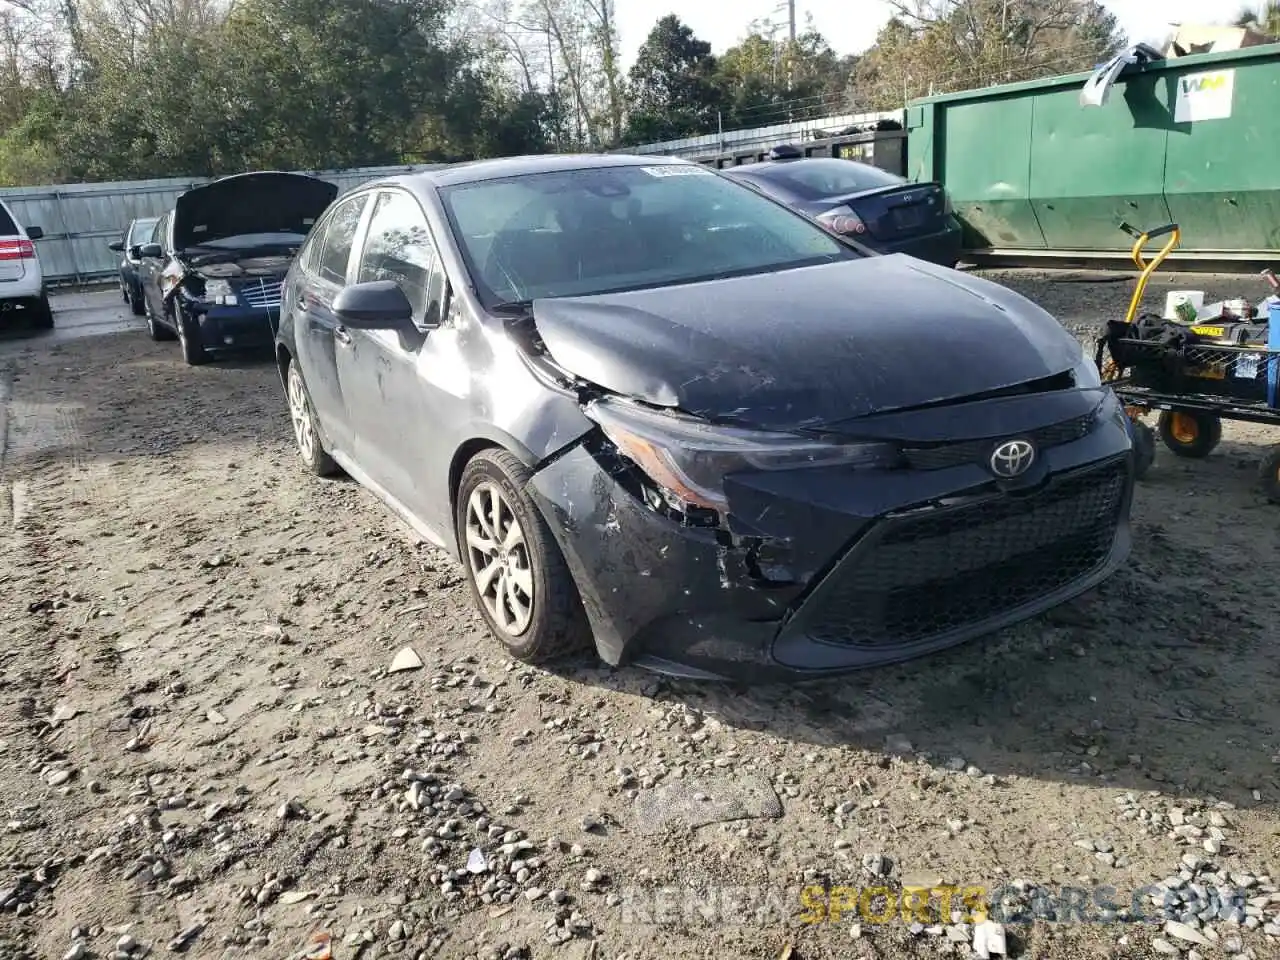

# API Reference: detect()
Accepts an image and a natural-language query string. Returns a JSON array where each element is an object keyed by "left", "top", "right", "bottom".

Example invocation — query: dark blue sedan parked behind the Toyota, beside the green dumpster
[{"left": 721, "top": 147, "right": 961, "bottom": 266}]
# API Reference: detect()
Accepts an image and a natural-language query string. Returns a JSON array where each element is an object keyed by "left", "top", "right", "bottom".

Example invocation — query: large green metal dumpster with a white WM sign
[{"left": 906, "top": 44, "right": 1280, "bottom": 260}]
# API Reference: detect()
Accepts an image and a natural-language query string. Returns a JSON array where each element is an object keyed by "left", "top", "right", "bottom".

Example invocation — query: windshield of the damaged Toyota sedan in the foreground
[{"left": 440, "top": 164, "right": 861, "bottom": 306}]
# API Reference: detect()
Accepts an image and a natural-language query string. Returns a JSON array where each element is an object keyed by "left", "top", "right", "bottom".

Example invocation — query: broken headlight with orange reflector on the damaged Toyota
[{"left": 585, "top": 401, "right": 899, "bottom": 513}]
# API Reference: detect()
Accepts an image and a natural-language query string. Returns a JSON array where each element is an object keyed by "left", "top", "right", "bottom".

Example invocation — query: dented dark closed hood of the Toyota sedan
[{"left": 532, "top": 255, "right": 1082, "bottom": 429}]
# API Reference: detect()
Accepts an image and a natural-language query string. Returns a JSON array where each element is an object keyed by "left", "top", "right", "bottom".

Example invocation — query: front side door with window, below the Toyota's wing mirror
[{"left": 338, "top": 189, "right": 470, "bottom": 535}]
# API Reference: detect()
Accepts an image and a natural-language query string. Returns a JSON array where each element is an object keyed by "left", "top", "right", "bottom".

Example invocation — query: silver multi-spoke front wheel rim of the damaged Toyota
[{"left": 466, "top": 481, "right": 534, "bottom": 636}]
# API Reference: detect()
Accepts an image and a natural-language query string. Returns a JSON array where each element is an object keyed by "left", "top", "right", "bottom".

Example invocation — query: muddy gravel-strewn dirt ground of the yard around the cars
[{"left": 0, "top": 273, "right": 1280, "bottom": 960}]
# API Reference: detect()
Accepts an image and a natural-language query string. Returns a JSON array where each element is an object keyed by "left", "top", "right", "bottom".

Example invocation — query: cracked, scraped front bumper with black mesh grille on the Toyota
[{"left": 529, "top": 391, "right": 1133, "bottom": 680}]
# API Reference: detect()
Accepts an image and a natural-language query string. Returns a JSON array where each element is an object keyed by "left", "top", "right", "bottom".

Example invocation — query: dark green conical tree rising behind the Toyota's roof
[{"left": 626, "top": 14, "right": 723, "bottom": 143}]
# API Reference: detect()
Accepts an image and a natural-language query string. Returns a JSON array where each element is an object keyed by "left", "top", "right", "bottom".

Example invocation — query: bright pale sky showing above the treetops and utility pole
[{"left": 616, "top": 0, "right": 1247, "bottom": 68}]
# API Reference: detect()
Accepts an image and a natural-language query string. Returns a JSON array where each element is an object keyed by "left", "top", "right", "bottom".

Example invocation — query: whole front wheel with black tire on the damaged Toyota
[{"left": 454, "top": 449, "right": 591, "bottom": 663}]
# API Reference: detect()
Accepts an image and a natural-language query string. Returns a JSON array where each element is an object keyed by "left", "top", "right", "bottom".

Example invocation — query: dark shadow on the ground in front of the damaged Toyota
[{"left": 545, "top": 436, "right": 1280, "bottom": 805}]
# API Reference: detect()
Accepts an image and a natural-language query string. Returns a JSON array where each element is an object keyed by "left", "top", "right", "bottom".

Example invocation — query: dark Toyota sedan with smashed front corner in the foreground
[{"left": 276, "top": 156, "right": 1133, "bottom": 678}]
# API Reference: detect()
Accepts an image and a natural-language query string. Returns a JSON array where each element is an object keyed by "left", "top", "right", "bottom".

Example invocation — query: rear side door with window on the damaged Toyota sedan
[{"left": 284, "top": 193, "right": 370, "bottom": 458}]
